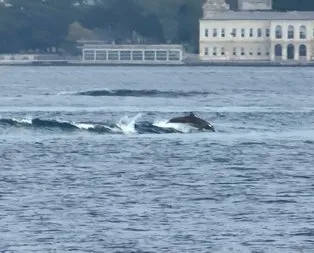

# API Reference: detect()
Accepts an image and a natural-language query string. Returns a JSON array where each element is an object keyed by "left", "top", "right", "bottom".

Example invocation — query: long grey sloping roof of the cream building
[{"left": 203, "top": 11, "right": 314, "bottom": 21}]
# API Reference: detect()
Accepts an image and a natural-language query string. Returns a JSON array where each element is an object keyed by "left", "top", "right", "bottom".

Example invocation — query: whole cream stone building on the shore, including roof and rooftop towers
[{"left": 200, "top": 0, "right": 314, "bottom": 62}]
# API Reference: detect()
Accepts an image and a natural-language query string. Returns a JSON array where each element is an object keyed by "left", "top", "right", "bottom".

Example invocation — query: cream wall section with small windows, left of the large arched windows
[{"left": 200, "top": 20, "right": 271, "bottom": 61}]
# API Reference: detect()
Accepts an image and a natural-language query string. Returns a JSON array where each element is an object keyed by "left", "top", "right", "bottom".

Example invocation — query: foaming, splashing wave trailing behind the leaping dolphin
[{"left": 0, "top": 114, "right": 209, "bottom": 135}]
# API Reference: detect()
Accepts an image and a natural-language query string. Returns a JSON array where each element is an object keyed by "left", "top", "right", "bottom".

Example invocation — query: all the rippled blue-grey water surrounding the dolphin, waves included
[{"left": 0, "top": 67, "right": 314, "bottom": 253}]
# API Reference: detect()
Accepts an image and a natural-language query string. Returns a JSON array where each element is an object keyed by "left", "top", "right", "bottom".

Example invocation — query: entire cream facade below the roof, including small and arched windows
[{"left": 200, "top": 17, "right": 314, "bottom": 62}]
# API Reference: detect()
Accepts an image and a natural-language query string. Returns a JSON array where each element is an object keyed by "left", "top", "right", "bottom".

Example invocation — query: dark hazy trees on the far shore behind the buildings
[{"left": 0, "top": 0, "right": 314, "bottom": 53}]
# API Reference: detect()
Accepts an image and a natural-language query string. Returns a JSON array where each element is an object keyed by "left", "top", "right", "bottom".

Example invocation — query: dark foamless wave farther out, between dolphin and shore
[{"left": 74, "top": 89, "right": 212, "bottom": 98}]
